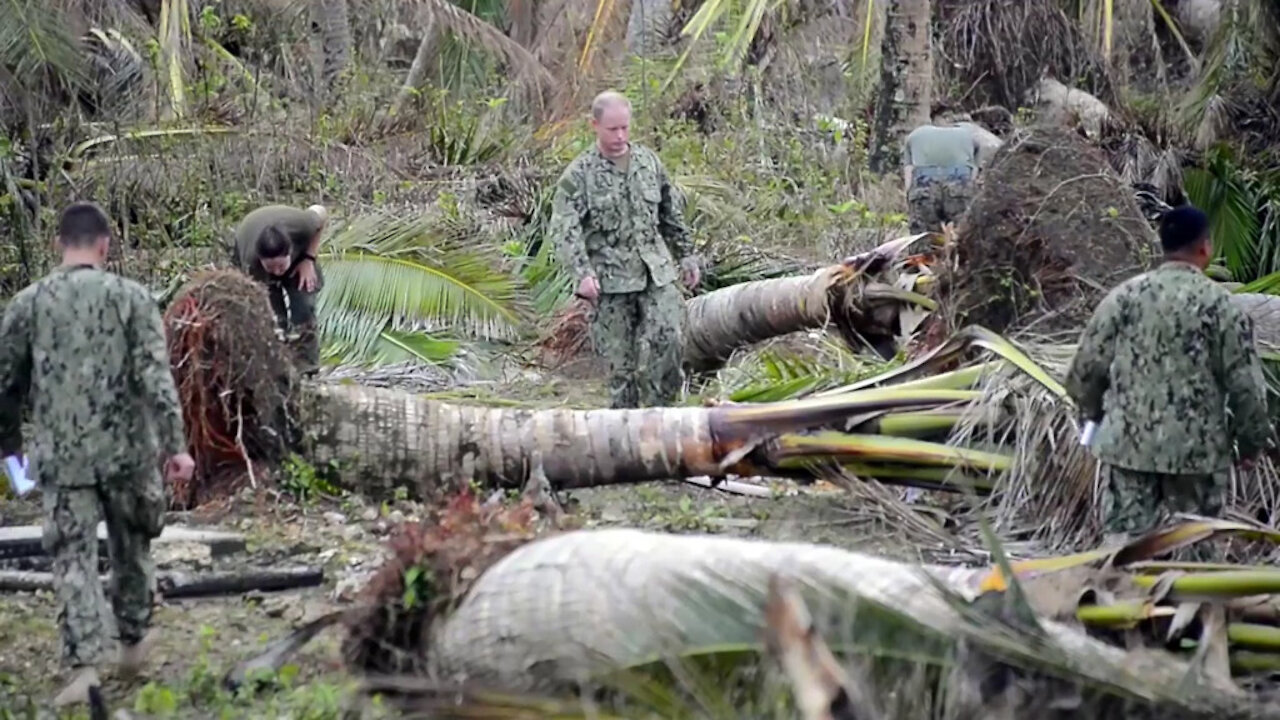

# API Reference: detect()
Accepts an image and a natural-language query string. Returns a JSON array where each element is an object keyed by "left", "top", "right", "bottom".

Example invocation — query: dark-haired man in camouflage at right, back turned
[{"left": 1066, "top": 205, "right": 1271, "bottom": 534}]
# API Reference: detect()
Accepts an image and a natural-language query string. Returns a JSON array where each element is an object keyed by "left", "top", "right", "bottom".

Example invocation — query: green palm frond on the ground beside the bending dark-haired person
[{"left": 316, "top": 207, "right": 527, "bottom": 363}]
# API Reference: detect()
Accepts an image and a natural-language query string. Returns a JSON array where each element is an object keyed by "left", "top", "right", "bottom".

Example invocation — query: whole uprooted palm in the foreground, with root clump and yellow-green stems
[{"left": 227, "top": 495, "right": 1280, "bottom": 717}]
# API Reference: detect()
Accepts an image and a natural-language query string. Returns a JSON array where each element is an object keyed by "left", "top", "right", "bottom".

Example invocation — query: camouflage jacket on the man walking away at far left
[{"left": 0, "top": 265, "right": 187, "bottom": 486}]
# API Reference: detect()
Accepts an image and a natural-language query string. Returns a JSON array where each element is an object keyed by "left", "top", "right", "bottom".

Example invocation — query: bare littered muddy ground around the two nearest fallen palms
[{"left": 0, "top": 373, "right": 982, "bottom": 719}]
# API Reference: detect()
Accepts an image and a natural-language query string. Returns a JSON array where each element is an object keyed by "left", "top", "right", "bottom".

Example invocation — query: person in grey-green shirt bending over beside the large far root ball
[{"left": 902, "top": 122, "right": 980, "bottom": 233}]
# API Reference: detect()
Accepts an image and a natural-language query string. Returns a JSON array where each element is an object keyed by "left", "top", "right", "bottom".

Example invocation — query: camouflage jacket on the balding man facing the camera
[{"left": 549, "top": 143, "right": 692, "bottom": 293}]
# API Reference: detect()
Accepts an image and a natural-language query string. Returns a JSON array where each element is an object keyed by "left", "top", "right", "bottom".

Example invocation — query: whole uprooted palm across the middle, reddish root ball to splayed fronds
[{"left": 168, "top": 260, "right": 1280, "bottom": 543}]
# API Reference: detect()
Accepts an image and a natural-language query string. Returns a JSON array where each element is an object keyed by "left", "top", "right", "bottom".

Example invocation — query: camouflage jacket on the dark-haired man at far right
[{"left": 1066, "top": 263, "right": 1271, "bottom": 474}]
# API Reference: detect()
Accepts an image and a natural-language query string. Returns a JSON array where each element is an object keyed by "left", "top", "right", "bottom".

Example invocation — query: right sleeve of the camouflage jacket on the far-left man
[{"left": 129, "top": 285, "right": 187, "bottom": 457}]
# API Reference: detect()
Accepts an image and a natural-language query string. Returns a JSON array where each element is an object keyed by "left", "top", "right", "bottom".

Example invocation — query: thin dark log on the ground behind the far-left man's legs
[{"left": 0, "top": 566, "right": 324, "bottom": 598}]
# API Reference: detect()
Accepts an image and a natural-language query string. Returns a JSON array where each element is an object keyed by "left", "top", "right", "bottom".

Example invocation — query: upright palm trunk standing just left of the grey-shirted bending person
[{"left": 870, "top": 0, "right": 933, "bottom": 173}]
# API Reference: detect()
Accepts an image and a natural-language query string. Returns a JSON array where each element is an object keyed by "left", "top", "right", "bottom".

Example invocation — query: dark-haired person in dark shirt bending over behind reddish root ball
[{"left": 232, "top": 205, "right": 329, "bottom": 373}]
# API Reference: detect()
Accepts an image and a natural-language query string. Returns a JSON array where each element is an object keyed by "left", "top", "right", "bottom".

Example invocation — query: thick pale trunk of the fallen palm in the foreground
[{"left": 312, "top": 529, "right": 1277, "bottom": 717}]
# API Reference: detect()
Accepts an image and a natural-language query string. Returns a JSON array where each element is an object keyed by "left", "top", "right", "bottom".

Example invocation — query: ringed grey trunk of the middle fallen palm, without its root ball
[{"left": 300, "top": 384, "right": 1007, "bottom": 496}]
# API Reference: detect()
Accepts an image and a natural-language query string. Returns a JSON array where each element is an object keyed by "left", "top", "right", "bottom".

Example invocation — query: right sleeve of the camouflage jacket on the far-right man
[{"left": 1219, "top": 304, "right": 1271, "bottom": 459}]
